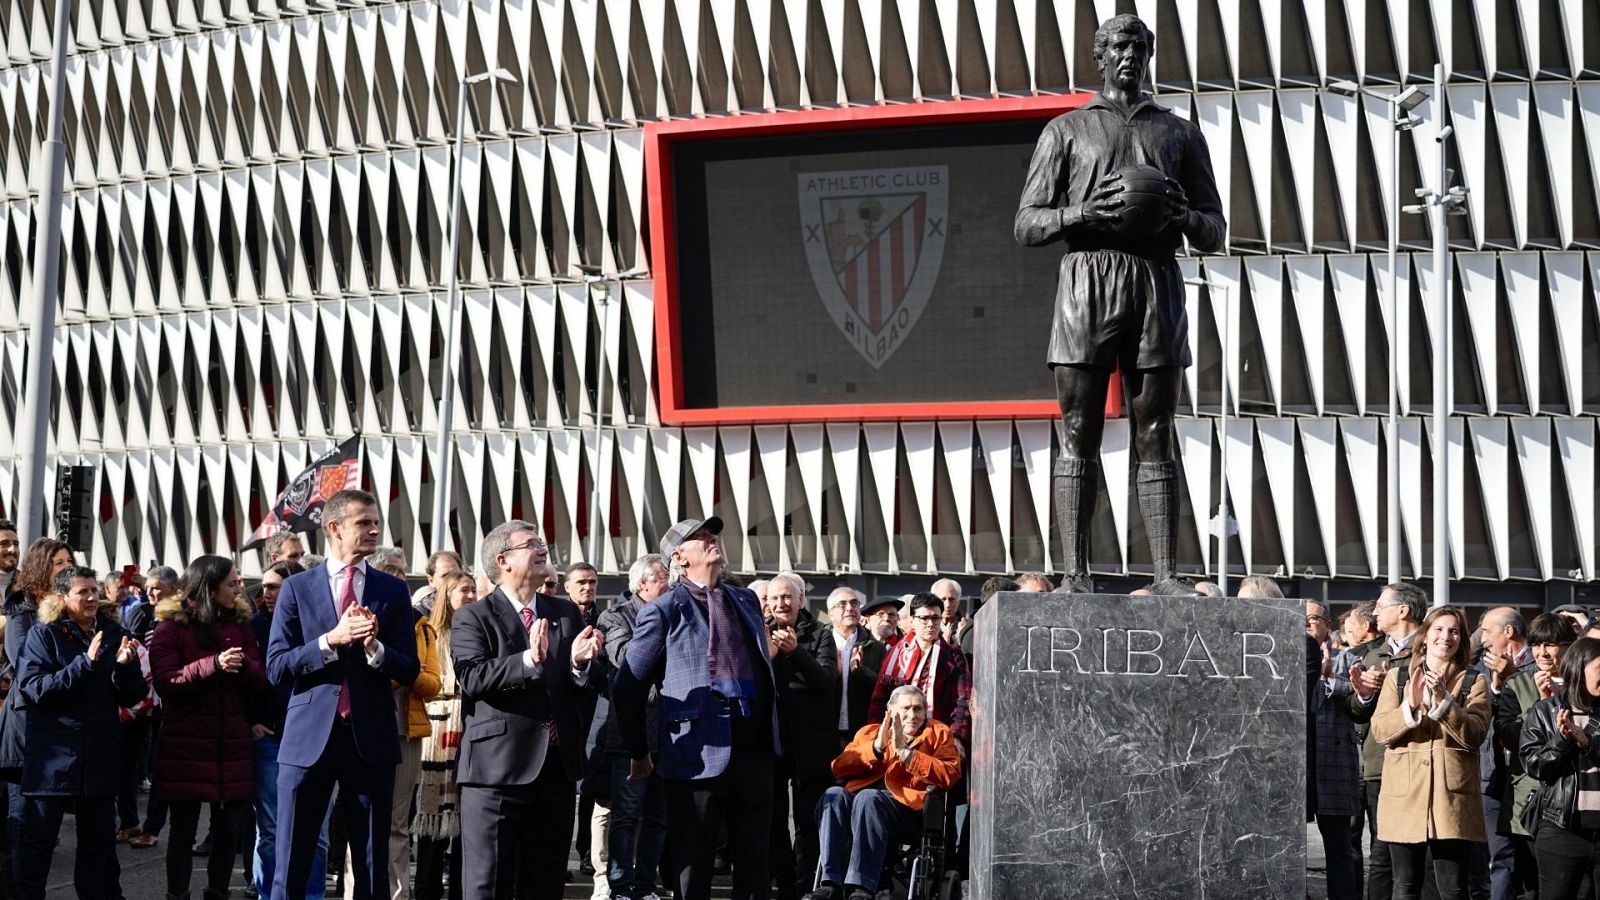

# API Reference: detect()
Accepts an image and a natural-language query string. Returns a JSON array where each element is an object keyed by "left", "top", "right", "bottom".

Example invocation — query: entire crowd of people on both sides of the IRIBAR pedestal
[{"left": 0, "top": 492, "right": 1600, "bottom": 900}]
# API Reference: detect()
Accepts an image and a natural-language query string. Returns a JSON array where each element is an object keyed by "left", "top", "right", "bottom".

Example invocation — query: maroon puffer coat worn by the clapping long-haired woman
[{"left": 150, "top": 601, "right": 267, "bottom": 802}]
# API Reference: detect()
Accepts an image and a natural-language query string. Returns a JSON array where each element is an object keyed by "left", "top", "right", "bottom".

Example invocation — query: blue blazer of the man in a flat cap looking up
[{"left": 611, "top": 581, "right": 782, "bottom": 780}]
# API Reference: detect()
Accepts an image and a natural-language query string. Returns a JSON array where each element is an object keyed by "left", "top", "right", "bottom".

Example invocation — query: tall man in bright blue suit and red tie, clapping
[{"left": 267, "top": 490, "right": 418, "bottom": 900}]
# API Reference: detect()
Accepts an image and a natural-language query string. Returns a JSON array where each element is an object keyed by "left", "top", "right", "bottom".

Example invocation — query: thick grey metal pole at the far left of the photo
[{"left": 16, "top": 0, "right": 72, "bottom": 534}]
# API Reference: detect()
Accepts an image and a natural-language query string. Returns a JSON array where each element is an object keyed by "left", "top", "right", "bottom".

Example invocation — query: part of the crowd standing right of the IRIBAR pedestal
[{"left": 1305, "top": 583, "right": 1600, "bottom": 900}]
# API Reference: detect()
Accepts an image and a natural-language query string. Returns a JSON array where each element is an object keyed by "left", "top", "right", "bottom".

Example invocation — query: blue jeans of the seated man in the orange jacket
[{"left": 816, "top": 786, "right": 922, "bottom": 890}]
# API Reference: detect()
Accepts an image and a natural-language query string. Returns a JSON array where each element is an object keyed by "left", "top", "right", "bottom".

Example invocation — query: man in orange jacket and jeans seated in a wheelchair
[{"left": 806, "top": 684, "right": 962, "bottom": 900}]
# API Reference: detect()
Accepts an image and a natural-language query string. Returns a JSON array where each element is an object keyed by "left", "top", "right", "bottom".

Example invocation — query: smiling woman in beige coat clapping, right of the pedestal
[{"left": 1373, "top": 607, "right": 1490, "bottom": 900}]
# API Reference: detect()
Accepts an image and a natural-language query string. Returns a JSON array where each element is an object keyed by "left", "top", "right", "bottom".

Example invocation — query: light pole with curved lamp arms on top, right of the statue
[{"left": 1328, "top": 82, "right": 1427, "bottom": 583}]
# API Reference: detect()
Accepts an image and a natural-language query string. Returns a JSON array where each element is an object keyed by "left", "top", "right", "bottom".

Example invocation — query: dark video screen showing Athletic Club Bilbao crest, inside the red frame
[{"left": 670, "top": 117, "right": 1061, "bottom": 410}]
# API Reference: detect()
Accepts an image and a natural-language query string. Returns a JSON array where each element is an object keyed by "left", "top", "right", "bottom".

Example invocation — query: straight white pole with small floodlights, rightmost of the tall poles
[{"left": 1432, "top": 66, "right": 1451, "bottom": 607}]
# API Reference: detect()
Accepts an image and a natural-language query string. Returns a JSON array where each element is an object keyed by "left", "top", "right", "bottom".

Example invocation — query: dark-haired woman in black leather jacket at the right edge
[{"left": 1520, "top": 637, "right": 1600, "bottom": 900}]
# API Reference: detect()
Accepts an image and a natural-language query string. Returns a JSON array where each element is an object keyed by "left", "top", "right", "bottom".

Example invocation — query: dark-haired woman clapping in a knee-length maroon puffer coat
[{"left": 150, "top": 556, "right": 267, "bottom": 900}]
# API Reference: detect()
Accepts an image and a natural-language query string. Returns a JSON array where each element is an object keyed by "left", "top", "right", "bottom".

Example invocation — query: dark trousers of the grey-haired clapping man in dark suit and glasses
[{"left": 461, "top": 746, "right": 578, "bottom": 900}]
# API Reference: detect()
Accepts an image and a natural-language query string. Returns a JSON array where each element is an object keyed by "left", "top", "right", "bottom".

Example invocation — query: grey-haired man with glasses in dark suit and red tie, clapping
[{"left": 450, "top": 519, "right": 602, "bottom": 900}]
